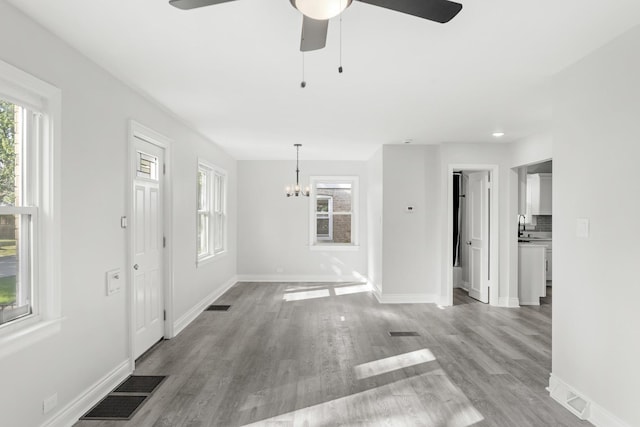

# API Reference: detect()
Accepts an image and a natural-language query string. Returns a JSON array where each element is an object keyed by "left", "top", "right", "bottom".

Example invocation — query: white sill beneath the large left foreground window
[{"left": 0, "top": 317, "right": 62, "bottom": 358}]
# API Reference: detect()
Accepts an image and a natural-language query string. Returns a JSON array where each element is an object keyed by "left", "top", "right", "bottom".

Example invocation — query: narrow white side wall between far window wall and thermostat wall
[{"left": 367, "top": 148, "right": 383, "bottom": 293}]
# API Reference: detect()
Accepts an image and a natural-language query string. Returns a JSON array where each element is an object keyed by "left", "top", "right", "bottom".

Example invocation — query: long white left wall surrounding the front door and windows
[{"left": 0, "top": 1, "right": 236, "bottom": 427}]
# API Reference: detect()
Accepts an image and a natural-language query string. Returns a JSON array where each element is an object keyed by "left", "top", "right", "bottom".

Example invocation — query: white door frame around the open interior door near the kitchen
[{"left": 442, "top": 163, "right": 500, "bottom": 306}]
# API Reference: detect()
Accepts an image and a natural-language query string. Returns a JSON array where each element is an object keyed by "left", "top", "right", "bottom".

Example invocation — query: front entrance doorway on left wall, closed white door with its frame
[{"left": 128, "top": 122, "right": 171, "bottom": 363}]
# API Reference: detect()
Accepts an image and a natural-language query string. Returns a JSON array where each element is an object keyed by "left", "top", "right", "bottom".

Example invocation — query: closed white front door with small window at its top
[{"left": 131, "top": 137, "right": 164, "bottom": 358}]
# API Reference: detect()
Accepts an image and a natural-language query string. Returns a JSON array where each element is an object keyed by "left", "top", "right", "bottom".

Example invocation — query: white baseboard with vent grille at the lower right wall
[{"left": 548, "top": 374, "right": 631, "bottom": 427}]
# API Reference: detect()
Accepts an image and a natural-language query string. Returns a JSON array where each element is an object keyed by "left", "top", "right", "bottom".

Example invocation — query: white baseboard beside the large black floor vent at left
[{"left": 42, "top": 359, "right": 133, "bottom": 427}]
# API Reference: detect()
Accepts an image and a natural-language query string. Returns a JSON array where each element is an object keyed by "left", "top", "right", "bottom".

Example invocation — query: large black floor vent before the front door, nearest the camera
[{"left": 80, "top": 375, "right": 167, "bottom": 420}]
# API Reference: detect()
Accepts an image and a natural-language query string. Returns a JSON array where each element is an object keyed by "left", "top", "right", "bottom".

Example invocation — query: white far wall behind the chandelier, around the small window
[{"left": 238, "top": 160, "right": 368, "bottom": 281}]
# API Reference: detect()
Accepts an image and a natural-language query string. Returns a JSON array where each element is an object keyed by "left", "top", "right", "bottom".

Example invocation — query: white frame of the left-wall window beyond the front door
[{"left": 196, "top": 159, "right": 228, "bottom": 266}]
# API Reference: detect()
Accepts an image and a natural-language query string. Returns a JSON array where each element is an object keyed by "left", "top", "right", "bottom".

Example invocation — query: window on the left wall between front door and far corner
[{"left": 197, "top": 162, "right": 227, "bottom": 264}]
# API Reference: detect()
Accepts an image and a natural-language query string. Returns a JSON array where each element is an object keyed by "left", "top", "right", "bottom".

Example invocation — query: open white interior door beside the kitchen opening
[{"left": 467, "top": 171, "right": 489, "bottom": 303}]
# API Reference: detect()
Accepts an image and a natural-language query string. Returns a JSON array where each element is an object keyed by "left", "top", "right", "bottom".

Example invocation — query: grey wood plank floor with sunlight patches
[{"left": 75, "top": 283, "right": 591, "bottom": 427}]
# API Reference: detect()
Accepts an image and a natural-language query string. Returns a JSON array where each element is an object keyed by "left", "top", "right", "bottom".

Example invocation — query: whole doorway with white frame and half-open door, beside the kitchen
[{"left": 445, "top": 165, "right": 499, "bottom": 305}]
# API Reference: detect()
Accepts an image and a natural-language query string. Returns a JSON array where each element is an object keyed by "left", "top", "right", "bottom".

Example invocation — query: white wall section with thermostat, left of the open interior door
[{"left": 382, "top": 145, "right": 441, "bottom": 302}]
